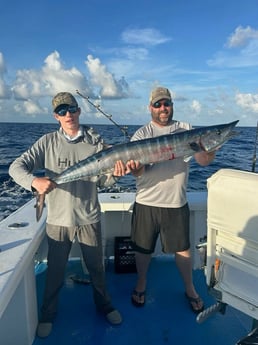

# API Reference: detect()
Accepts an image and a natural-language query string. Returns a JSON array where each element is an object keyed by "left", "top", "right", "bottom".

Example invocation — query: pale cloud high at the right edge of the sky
[{"left": 207, "top": 26, "right": 258, "bottom": 68}]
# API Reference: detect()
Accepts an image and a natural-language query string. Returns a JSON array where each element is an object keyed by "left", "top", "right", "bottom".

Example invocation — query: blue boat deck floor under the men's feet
[{"left": 33, "top": 256, "right": 252, "bottom": 345}]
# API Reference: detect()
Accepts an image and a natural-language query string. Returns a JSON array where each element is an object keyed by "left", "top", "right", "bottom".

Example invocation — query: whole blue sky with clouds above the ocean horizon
[{"left": 0, "top": 0, "right": 258, "bottom": 126}]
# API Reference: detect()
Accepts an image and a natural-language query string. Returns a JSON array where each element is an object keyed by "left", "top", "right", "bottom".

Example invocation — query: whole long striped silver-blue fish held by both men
[{"left": 36, "top": 120, "right": 238, "bottom": 220}]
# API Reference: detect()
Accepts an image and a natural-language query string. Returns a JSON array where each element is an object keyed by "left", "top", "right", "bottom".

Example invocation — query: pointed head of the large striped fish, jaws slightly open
[{"left": 200, "top": 120, "right": 239, "bottom": 152}]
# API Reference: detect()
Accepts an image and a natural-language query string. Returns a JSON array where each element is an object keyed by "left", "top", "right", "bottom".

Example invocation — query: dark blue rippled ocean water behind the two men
[{"left": 0, "top": 123, "right": 257, "bottom": 220}]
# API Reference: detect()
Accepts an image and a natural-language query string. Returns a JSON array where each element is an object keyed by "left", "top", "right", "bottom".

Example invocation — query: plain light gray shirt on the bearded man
[{"left": 131, "top": 120, "right": 191, "bottom": 208}]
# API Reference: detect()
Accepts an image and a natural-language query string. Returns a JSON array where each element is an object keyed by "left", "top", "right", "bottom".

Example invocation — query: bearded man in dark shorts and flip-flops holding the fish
[{"left": 125, "top": 87, "right": 215, "bottom": 313}]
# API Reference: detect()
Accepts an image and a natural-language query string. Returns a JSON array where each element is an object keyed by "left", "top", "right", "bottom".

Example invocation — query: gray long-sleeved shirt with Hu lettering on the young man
[{"left": 9, "top": 126, "right": 114, "bottom": 227}]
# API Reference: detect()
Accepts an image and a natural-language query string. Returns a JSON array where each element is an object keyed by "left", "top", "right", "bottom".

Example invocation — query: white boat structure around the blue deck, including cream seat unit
[{"left": 0, "top": 170, "right": 258, "bottom": 345}]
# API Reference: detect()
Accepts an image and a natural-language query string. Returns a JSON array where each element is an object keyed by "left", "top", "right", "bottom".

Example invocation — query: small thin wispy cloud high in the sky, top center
[{"left": 122, "top": 28, "right": 171, "bottom": 46}]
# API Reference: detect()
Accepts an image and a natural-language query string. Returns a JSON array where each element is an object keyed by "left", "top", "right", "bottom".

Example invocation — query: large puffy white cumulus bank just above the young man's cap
[{"left": 9, "top": 51, "right": 128, "bottom": 100}]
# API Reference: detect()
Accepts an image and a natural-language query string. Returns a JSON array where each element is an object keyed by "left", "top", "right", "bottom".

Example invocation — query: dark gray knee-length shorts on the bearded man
[{"left": 131, "top": 202, "right": 190, "bottom": 254}]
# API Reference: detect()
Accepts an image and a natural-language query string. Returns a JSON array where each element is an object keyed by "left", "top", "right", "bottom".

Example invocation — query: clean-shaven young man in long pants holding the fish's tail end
[{"left": 9, "top": 92, "right": 122, "bottom": 337}]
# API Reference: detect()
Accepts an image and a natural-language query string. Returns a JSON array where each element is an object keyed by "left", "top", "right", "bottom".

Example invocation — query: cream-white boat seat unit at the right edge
[{"left": 205, "top": 169, "right": 258, "bottom": 319}]
